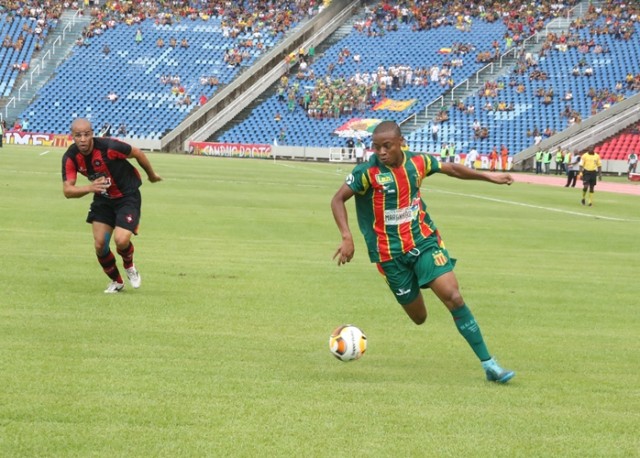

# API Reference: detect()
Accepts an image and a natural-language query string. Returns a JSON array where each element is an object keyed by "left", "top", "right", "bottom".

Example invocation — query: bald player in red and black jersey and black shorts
[{"left": 62, "top": 118, "right": 162, "bottom": 293}]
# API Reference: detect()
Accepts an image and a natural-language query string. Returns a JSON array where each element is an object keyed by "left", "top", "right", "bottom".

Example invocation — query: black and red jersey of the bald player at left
[{"left": 62, "top": 137, "right": 142, "bottom": 199}]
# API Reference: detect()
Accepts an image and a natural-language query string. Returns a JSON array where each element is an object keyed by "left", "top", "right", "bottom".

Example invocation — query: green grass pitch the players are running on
[{"left": 0, "top": 146, "right": 640, "bottom": 457}]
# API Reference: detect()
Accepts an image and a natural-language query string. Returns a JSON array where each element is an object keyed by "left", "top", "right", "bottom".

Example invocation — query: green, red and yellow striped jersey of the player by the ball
[{"left": 346, "top": 152, "right": 440, "bottom": 262}]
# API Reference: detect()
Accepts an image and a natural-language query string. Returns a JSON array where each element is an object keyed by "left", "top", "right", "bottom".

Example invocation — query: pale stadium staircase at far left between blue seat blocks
[{"left": 0, "top": 10, "right": 91, "bottom": 126}]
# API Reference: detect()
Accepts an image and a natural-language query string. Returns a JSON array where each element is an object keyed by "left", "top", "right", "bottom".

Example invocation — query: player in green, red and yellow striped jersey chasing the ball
[{"left": 331, "top": 121, "right": 515, "bottom": 383}]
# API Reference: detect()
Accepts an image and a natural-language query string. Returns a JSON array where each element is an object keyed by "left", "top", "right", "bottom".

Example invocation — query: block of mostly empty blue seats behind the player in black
[{"left": 22, "top": 13, "right": 292, "bottom": 139}]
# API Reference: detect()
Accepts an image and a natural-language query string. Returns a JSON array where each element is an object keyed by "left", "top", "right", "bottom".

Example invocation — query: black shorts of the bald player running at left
[{"left": 87, "top": 191, "right": 142, "bottom": 234}]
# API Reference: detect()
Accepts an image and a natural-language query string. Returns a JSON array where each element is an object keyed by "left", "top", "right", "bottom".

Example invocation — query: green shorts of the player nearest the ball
[{"left": 377, "top": 243, "right": 456, "bottom": 305}]
